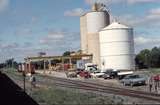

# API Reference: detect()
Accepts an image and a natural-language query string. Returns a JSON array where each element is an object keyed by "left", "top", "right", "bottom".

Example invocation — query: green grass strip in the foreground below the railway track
[{"left": 32, "top": 87, "right": 123, "bottom": 105}]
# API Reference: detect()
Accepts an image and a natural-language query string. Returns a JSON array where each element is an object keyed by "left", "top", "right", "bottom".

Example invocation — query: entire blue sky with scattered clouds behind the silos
[{"left": 0, "top": 0, "right": 160, "bottom": 62}]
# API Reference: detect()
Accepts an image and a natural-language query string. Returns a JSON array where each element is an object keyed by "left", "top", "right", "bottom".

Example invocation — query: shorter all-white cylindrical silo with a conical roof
[{"left": 100, "top": 22, "right": 135, "bottom": 70}]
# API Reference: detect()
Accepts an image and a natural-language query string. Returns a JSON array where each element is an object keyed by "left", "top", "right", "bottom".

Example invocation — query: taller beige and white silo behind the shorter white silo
[{"left": 80, "top": 3, "right": 110, "bottom": 66}]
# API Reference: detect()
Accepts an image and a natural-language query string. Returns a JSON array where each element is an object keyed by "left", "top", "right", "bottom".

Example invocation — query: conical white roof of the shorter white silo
[{"left": 102, "top": 22, "right": 131, "bottom": 30}]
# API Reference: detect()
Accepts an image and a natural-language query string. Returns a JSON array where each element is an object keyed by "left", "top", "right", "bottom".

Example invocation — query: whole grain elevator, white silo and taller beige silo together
[{"left": 80, "top": 3, "right": 135, "bottom": 70}]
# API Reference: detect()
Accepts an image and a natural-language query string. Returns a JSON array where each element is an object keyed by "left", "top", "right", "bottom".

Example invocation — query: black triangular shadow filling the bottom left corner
[{"left": 0, "top": 72, "right": 38, "bottom": 105}]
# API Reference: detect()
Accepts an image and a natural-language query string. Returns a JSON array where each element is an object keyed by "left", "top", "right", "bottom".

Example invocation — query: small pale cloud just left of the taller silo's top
[{"left": 64, "top": 8, "right": 85, "bottom": 16}]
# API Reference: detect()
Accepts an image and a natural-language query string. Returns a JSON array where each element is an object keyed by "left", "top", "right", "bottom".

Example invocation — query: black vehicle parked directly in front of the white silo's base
[{"left": 103, "top": 69, "right": 118, "bottom": 79}]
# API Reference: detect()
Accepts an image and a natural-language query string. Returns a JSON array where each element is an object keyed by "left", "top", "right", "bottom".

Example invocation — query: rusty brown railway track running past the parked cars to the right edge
[{"left": 39, "top": 76, "right": 160, "bottom": 103}]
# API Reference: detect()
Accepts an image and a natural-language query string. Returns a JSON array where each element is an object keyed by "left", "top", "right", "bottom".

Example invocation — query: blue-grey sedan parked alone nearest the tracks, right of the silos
[{"left": 120, "top": 75, "right": 146, "bottom": 86}]
